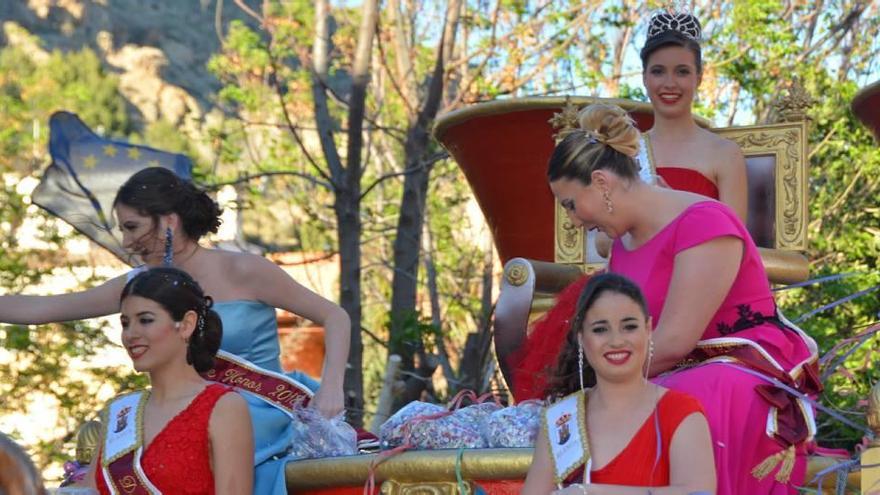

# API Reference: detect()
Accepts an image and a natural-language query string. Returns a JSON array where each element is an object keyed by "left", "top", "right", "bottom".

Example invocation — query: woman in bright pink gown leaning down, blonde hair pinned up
[{"left": 548, "top": 105, "right": 820, "bottom": 495}]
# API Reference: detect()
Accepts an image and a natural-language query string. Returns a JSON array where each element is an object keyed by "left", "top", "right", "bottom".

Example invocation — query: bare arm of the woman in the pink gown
[{"left": 649, "top": 236, "right": 743, "bottom": 376}]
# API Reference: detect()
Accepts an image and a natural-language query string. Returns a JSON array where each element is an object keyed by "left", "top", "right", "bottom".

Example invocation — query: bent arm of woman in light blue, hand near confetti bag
[{"left": 240, "top": 255, "right": 351, "bottom": 418}]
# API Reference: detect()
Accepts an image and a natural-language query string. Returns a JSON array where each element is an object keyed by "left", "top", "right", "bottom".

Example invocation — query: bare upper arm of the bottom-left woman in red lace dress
[{"left": 208, "top": 393, "right": 254, "bottom": 495}]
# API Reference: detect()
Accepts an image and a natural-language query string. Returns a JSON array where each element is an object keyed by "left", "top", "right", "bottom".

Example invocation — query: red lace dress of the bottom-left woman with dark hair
[{"left": 95, "top": 383, "right": 232, "bottom": 495}]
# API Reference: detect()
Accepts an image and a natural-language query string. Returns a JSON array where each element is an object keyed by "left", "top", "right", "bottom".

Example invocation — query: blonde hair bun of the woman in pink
[{"left": 578, "top": 103, "right": 639, "bottom": 157}]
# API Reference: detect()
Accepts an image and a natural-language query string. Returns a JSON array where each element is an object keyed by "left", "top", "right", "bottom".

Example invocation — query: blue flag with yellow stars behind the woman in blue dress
[{"left": 31, "top": 112, "right": 193, "bottom": 264}]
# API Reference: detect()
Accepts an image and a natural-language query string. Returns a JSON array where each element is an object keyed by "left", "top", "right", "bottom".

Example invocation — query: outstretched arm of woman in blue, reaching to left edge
[{"left": 0, "top": 275, "right": 126, "bottom": 325}]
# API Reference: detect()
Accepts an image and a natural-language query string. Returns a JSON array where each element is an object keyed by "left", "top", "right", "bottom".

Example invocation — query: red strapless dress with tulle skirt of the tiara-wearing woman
[{"left": 508, "top": 167, "right": 718, "bottom": 402}]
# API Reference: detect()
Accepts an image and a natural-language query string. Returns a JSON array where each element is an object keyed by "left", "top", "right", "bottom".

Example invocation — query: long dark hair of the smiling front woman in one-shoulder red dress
[{"left": 545, "top": 273, "right": 648, "bottom": 397}]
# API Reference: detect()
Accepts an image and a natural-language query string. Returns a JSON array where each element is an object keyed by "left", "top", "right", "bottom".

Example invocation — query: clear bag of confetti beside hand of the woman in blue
[{"left": 291, "top": 407, "right": 358, "bottom": 459}]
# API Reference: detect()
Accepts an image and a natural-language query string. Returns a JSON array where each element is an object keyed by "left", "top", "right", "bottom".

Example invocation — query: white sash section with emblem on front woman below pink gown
[{"left": 542, "top": 391, "right": 590, "bottom": 483}]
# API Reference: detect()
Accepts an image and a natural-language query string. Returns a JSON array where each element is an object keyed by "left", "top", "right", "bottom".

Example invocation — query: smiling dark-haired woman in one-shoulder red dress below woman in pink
[{"left": 523, "top": 273, "right": 715, "bottom": 495}]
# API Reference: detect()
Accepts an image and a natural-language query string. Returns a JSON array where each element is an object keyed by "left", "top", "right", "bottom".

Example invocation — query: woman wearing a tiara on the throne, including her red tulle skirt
[{"left": 510, "top": 12, "right": 748, "bottom": 401}]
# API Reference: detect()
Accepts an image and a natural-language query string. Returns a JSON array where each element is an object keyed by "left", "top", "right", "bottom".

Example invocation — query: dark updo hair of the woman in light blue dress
[{"left": 113, "top": 167, "right": 222, "bottom": 241}]
